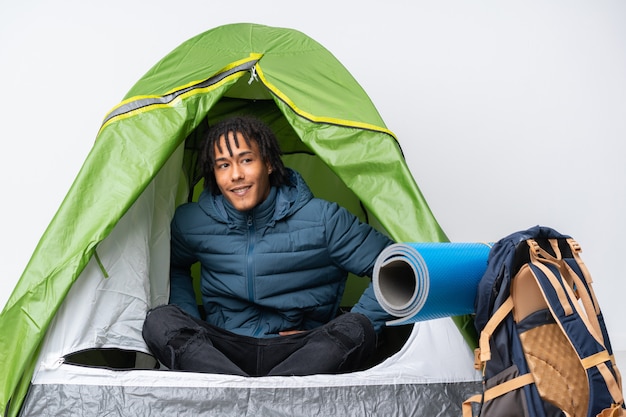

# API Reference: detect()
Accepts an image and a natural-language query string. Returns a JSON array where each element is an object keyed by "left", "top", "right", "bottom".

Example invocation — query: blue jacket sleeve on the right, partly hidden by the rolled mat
[{"left": 326, "top": 203, "right": 393, "bottom": 332}]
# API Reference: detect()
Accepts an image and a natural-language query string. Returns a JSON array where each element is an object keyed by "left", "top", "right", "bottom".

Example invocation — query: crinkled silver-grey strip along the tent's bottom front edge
[{"left": 22, "top": 378, "right": 481, "bottom": 417}]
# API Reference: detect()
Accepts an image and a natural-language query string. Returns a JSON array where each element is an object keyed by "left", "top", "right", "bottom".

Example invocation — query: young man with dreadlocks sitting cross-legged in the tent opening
[{"left": 143, "top": 117, "right": 392, "bottom": 376}]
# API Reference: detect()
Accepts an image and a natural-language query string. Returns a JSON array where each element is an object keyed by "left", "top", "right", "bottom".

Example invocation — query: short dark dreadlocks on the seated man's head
[{"left": 200, "top": 116, "right": 290, "bottom": 195}]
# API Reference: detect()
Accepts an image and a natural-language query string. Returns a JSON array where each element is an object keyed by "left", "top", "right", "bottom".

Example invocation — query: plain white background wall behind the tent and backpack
[{"left": 0, "top": 0, "right": 626, "bottom": 350}]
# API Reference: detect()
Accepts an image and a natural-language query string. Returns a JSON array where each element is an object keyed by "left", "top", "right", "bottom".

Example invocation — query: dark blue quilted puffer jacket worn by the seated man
[{"left": 170, "top": 171, "right": 392, "bottom": 337}]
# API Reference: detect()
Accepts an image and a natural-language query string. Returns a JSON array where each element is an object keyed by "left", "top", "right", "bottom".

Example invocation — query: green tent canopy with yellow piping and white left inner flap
[{"left": 0, "top": 23, "right": 478, "bottom": 415}]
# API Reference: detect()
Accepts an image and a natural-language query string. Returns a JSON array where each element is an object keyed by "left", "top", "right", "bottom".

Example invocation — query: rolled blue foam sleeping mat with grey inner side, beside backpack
[{"left": 372, "top": 242, "right": 491, "bottom": 325}]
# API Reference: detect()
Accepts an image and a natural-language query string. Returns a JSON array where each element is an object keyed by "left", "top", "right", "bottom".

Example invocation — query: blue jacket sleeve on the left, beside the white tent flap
[{"left": 170, "top": 211, "right": 200, "bottom": 318}]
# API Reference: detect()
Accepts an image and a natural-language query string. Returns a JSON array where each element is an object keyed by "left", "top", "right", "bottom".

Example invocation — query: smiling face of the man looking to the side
[{"left": 213, "top": 132, "right": 272, "bottom": 211}]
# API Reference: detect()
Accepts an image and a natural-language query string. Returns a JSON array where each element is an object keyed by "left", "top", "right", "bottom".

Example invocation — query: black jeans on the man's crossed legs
[{"left": 143, "top": 305, "right": 376, "bottom": 376}]
